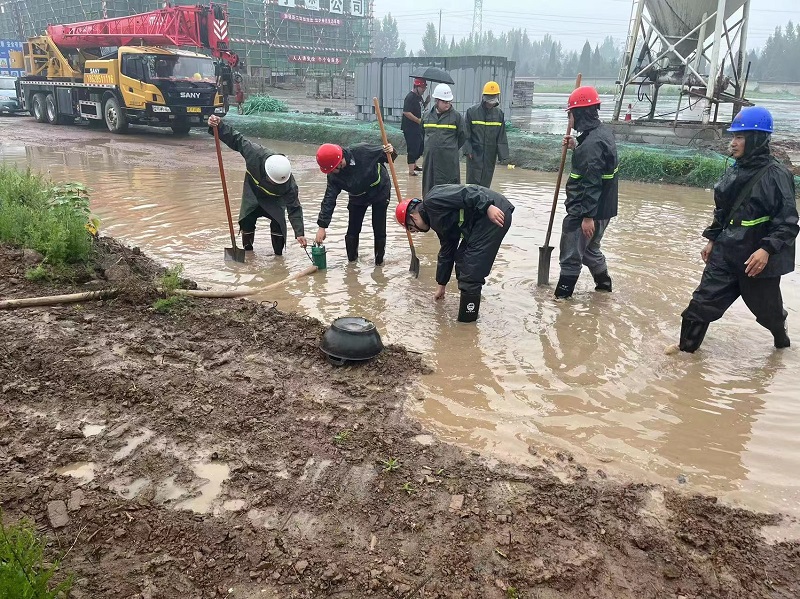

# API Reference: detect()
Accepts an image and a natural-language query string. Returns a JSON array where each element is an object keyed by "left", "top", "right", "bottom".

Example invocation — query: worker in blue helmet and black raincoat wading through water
[{"left": 678, "top": 106, "right": 800, "bottom": 353}]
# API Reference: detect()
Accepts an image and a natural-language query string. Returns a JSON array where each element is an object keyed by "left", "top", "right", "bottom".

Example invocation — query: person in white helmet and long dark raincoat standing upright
[{"left": 422, "top": 83, "right": 467, "bottom": 198}]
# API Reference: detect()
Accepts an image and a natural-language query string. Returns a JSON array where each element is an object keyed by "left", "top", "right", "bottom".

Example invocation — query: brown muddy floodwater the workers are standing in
[{"left": 0, "top": 136, "right": 800, "bottom": 513}]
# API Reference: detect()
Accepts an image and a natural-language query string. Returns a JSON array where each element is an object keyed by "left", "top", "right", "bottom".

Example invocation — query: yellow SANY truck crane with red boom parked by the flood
[{"left": 10, "top": 4, "right": 240, "bottom": 134}]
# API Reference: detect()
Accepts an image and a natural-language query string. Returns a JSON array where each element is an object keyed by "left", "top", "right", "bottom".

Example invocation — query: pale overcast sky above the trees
[{"left": 374, "top": 0, "right": 800, "bottom": 54}]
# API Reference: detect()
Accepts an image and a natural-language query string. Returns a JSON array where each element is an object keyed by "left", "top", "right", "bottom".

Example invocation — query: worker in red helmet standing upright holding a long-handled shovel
[{"left": 555, "top": 86, "right": 619, "bottom": 298}]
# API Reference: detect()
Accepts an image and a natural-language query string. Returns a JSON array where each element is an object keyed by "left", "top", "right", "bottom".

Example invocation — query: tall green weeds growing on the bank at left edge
[{"left": 0, "top": 165, "right": 99, "bottom": 266}]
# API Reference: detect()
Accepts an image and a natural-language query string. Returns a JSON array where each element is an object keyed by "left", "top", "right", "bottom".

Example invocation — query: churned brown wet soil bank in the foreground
[{"left": 0, "top": 241, "right": 800, "bottom": 599}]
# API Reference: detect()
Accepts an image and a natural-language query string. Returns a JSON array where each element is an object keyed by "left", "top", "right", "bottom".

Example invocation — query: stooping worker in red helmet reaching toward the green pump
[{"left": 316, "top": 143, "right": 397, "bottom": 266}]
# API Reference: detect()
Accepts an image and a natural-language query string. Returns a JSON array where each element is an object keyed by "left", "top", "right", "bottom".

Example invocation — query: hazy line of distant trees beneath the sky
[{"left": 373, "top": 14, "right": 800, "bottom": 81}]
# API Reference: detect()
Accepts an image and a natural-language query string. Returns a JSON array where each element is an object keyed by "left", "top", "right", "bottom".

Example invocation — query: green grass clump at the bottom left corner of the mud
[{"left": 0, "top": 512, "right": 72, "bottom": 599}]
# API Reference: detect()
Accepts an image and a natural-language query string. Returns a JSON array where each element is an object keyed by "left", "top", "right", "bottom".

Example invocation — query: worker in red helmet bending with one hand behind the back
[{"left": 395, "top": 185, "right": 514, "bottom": 322}]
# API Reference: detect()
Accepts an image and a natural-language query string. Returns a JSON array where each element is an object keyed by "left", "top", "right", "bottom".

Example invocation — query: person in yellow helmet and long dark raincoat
[{"left": 462, "top": 81, "right": 508, "bottom": 187}]
